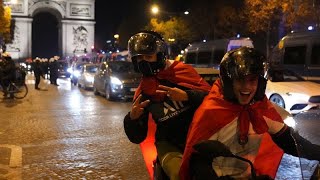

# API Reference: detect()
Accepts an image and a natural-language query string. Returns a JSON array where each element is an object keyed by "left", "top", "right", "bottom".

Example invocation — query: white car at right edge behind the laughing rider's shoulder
[{"left": 266, "top": 68, "right": 320, "bottom": 114}]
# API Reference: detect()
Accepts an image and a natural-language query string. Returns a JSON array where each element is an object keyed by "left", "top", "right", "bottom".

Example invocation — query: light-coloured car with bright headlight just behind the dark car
[{"left": 78, "top": 64, "right": 99, "bottom": 89}]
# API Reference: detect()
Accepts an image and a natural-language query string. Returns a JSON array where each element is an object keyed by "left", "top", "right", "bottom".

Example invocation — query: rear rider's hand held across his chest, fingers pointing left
[{"left": 156, "top": 85, "right": 189, "bottom": 101}]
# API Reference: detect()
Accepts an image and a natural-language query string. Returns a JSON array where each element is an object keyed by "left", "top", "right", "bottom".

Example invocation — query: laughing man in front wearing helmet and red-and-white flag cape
[{"left": 180, "top": 47, "right": 320, "bottom": 180}]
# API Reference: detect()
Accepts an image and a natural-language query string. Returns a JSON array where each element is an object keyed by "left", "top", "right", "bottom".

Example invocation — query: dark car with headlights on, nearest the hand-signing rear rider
[{"left": 93, "top": 61, "right": 141, "bottom": 100}]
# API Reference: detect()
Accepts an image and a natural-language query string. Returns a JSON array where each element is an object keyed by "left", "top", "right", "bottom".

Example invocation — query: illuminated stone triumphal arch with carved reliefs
[{"left": 6, "top": 0, "right": 95, "bottom": 59}]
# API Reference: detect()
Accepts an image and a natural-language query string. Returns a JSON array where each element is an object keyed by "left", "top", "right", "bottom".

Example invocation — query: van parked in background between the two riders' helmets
[{"left": 183, "top": 38, "right": 253, "bottom": 69}]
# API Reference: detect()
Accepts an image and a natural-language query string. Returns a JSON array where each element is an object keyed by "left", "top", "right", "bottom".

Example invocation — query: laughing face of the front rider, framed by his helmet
[{"left": 233, "top": 75, "right": 259, "bottom": 105}]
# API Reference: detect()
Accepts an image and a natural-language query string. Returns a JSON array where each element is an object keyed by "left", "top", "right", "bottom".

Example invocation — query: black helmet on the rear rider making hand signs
[{"left": 128, "top": 31, "right": 167, "bottom": 76}]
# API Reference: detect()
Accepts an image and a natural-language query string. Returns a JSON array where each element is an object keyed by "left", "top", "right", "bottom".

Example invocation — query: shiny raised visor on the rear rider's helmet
[{"left": 128, "top": 33, "right": 165, "bottom": 57}]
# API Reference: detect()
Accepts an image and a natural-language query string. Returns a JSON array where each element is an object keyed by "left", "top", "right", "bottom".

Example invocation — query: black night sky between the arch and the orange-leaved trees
[{"left": 95, "top": 0, "right": 191, "bottom": 46}]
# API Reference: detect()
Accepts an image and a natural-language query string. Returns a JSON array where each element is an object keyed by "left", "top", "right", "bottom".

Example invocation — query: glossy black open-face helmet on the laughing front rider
[{"left": 220, "top": 47, "right": 267, "bottom": 103}]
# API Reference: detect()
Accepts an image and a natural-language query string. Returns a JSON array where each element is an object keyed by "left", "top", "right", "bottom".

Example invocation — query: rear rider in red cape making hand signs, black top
[{"left": 124, "top": 31, "right": 211, "bottom": 179}]
